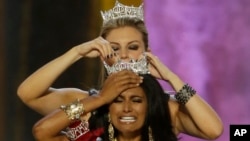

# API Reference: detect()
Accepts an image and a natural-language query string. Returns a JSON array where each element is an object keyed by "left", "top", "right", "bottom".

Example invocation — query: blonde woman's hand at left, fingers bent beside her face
[{"left": 75, "top": 37, "right": 115, "bottom": 59}]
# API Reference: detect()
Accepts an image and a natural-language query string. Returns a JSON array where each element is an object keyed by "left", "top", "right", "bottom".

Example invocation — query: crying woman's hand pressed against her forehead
[{"left": 99, "top": 70, "right": 143, "bottom": 104}]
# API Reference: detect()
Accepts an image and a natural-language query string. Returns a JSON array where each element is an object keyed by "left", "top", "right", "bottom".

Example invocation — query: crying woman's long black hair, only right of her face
[{"left": 140, "top": 74, "right": 177, "bottom": 141}]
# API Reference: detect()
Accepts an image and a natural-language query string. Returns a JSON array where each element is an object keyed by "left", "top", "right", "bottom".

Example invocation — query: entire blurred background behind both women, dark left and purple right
[{"left": 0, "top": 0, "right": 250, "bottom": 141}]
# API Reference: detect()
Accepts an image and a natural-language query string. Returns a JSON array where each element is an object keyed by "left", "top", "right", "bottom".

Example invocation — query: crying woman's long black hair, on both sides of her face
[{"left": 90, "top": 74, "right": 177, "bottom": 141}]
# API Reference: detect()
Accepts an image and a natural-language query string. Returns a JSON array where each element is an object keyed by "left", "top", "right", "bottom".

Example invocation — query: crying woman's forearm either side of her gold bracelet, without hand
[{"left": 33, "top": 96, "right": 104, "bottom": 141}]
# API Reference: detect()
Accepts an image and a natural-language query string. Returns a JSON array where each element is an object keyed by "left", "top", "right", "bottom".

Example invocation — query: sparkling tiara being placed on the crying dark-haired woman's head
[{"left": 103, "top": 54, "right": 150, "bottom": 75}]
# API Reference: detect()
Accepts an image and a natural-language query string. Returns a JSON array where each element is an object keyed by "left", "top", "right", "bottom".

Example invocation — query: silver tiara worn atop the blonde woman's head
[{"left": 101, "top": 1, "right": 143, "bottom": 23}]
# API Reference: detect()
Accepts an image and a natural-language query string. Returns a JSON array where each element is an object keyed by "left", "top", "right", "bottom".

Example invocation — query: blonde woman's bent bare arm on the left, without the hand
[{"left": 17, "top": 48, "right": 85, "bottom": 114}]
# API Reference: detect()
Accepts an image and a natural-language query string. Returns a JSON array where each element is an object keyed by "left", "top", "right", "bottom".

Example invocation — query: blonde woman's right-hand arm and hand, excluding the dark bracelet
[{"left": 147, "top": 53, "right": 223, "bottom": 139}]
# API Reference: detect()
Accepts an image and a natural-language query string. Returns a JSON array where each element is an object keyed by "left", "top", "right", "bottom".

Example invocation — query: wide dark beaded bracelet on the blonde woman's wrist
[{"left": 175, "top": 84, "right": 196, "bottom": 105}]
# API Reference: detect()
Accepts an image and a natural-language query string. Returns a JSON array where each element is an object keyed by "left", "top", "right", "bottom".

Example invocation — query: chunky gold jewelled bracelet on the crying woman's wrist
[{"left": 60, "top": 99, "right": 84, "bottom": 121}]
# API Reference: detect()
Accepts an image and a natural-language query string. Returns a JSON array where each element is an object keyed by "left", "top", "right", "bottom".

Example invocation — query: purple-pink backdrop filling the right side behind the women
[{"left": 144, "top": 0, "right": 250, "bottom": 141}]
